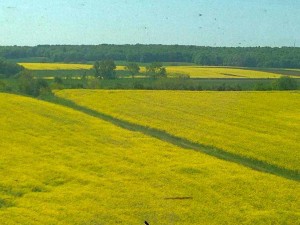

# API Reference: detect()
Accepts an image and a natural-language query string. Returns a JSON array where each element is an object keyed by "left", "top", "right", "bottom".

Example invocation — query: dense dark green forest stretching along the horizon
[{"left": 0, "top": 44, "right": 300, "bottom": 68}]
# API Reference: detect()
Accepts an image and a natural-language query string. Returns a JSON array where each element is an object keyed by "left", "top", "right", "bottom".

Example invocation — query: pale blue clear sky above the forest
[{"left": 0, "top": 0, "right": 300, "bottom": 47}]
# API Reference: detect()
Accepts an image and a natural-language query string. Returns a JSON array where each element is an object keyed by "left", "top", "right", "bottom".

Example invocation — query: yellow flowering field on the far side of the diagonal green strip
[{"left": 56, "top": 90, "right": 300, "bottom": 172}]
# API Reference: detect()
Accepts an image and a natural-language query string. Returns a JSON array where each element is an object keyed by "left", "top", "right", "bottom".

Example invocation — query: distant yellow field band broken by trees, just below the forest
[{"left": 19, "top": 63, "right": 299, "bottom": 79}]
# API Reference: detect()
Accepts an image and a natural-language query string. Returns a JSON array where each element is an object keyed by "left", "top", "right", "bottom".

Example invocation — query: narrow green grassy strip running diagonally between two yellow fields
[{"left": 43, "top": 96, "right": 300, "bottom": 182}]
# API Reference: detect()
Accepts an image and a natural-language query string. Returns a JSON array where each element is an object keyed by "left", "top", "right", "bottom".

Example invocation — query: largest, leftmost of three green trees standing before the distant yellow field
[{"left": 93, "top": 60, "right": 117, "bottom": 79}]
